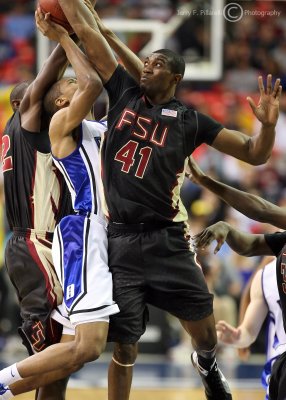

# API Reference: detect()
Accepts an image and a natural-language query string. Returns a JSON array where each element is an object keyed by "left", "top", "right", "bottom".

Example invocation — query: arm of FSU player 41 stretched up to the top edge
[{"left": 59, "top": 0, "right": 118, "bottom": 83}]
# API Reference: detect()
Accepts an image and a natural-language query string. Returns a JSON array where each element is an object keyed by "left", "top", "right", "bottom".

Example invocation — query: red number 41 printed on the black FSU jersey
[{"left": 114, "top": 140, "right": 152, "bottom": 179}]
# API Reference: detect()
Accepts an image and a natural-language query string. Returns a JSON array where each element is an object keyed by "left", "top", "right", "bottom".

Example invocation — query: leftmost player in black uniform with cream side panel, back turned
[{"left": 2, "top": 31, "right": 75, "bottom": 400}]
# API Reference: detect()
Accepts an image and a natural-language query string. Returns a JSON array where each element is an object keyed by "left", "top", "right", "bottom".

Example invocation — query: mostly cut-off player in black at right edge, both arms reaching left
[{"left": 189, "top": 158, "right": 286, "bottom": 400}]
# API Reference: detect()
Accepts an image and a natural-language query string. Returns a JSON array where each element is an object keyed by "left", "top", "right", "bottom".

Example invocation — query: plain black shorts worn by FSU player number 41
[{"left": 108, "top": 223, "right": 213, "bottom": 344}]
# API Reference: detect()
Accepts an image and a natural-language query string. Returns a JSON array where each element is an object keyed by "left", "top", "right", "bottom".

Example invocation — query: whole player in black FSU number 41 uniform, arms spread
[{"left": 54, "top": 0, "right": 281, "bottom": 400}]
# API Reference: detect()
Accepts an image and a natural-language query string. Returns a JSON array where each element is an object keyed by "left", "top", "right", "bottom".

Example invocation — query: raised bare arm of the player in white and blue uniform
[{"left": 37, "top": 13, "right": 102, "bottom": 157}]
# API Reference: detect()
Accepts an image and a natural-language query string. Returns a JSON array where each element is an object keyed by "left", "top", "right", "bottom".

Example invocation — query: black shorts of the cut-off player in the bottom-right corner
[{"left": 269, "top": 352, "right": 286, "bottom": 400}]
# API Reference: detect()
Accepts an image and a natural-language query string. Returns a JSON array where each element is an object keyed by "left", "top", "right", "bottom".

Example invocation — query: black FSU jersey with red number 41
[{"left": 102, "top": 66, "right": 222, "bottom": 223}]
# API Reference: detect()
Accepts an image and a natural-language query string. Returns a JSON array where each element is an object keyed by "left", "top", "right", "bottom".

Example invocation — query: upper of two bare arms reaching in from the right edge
[{"left": 189, "top": 157, "right": 286, "bottom": 229}]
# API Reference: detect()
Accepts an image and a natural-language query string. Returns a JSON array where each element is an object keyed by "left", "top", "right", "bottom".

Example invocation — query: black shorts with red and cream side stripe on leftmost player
[{"left": 5, "top": 228, "right": 62, "bottom": 354}]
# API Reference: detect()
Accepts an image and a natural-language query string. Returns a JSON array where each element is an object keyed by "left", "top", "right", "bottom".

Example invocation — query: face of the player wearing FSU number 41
[{"left": 140, "top": 53, "right": 175, "bottom": 95}]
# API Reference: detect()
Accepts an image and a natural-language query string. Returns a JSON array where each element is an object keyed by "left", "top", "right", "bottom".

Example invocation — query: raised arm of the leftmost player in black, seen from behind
[{"left": 20, "top": 8, "right": 73, "bottom": 132}]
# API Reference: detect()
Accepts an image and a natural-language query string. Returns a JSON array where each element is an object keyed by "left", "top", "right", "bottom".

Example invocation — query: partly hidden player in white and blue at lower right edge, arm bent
[{"left": 216, "top": 259, "right": 286, "bottom": 400}]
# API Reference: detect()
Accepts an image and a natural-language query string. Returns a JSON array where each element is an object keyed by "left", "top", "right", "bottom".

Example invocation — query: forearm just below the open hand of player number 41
[{"left": 249, "top": 125, "right": 275, "bottom": 165}]
